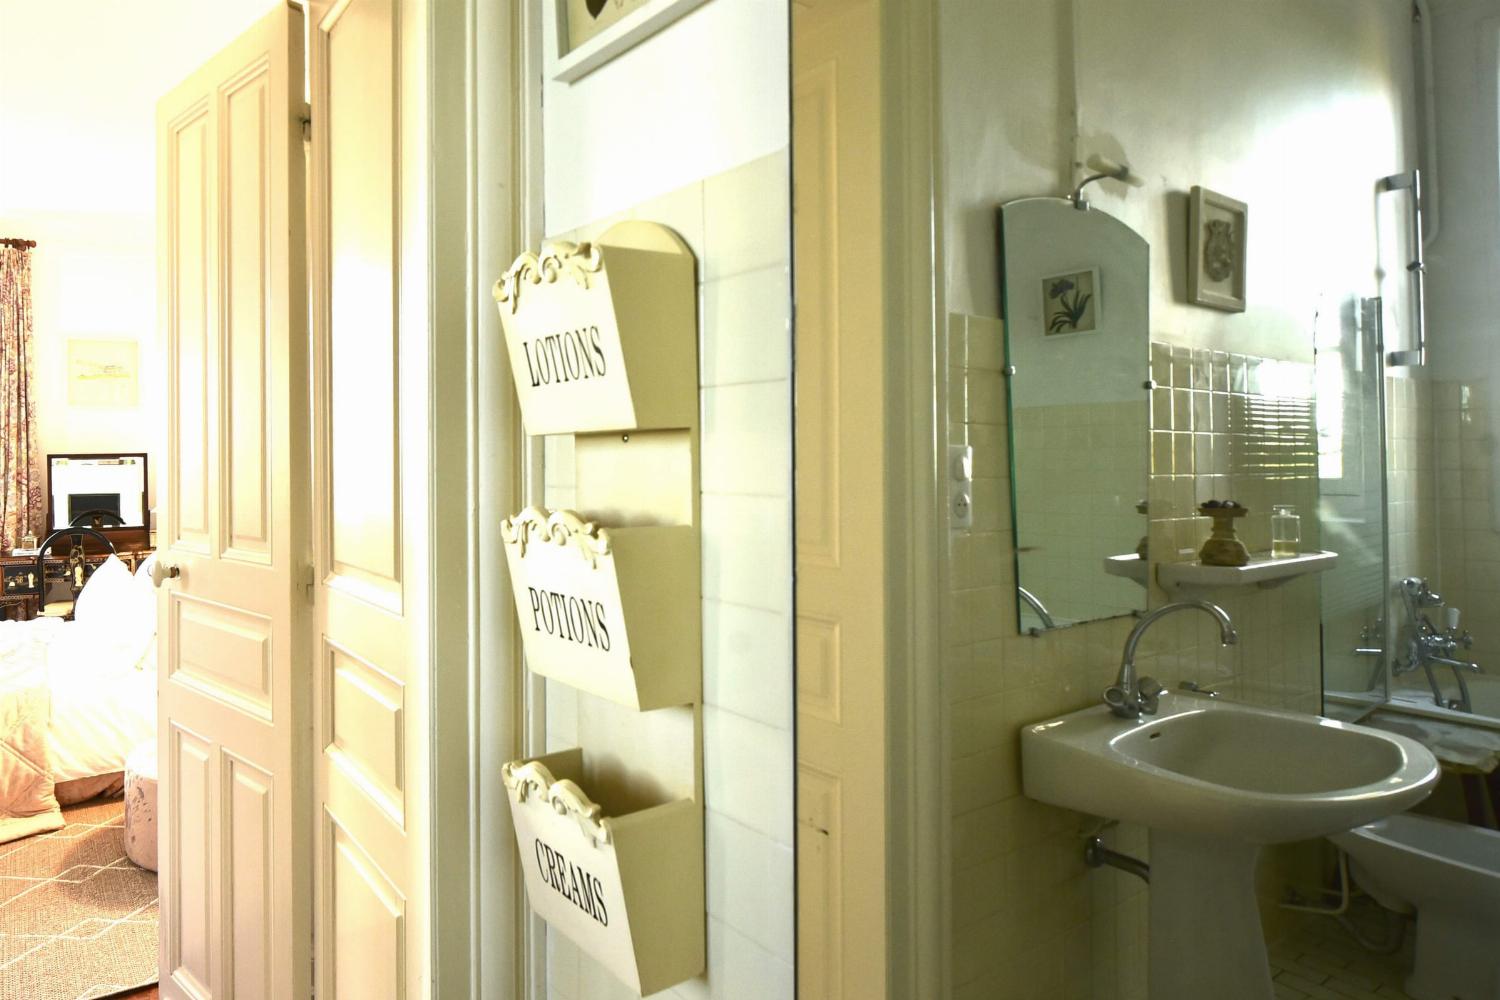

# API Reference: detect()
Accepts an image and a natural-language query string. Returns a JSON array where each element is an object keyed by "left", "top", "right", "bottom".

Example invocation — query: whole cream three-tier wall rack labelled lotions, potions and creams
[{"left": 495, "top": 222, "right": 705, "bottom": 996}]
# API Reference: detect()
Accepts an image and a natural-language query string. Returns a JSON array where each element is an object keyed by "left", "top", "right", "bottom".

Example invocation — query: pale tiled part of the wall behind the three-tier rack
[{"left": 545, "top": 151, "right": 797, "bottom": 1000}]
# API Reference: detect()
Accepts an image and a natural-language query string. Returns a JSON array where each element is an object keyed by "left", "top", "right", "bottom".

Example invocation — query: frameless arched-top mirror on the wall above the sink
[{"left": 1001, "top": 198, "right": 1151, "bottom": 633}]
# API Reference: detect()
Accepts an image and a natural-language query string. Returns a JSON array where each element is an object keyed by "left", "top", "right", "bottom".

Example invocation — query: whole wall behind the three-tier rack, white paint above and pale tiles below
[{"left": 531, "top": 0, "right": 795, "bottom": 1000}]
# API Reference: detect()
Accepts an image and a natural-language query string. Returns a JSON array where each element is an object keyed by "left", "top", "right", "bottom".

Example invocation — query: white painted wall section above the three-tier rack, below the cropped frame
[{"left": 542, "top": 0, "right": 791, "bottom": 232}]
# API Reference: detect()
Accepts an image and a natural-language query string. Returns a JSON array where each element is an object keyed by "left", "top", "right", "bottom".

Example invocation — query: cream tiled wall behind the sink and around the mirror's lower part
[{"left": 944, "top": 315, "right": 1320, "bottom": 1000}]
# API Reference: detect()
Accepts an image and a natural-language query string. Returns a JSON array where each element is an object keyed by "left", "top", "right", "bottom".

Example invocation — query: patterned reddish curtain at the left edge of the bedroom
[{"left": 0, "top": 244, "right": 47, "bottom": 555}]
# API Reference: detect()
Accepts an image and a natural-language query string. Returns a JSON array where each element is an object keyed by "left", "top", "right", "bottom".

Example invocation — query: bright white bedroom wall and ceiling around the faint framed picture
[{"left": 0, "top": 0, "right": 275, "bottom": 502}]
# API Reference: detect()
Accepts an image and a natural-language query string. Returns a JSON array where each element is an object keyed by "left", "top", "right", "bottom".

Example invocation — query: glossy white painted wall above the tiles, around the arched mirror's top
[{"left": 941, "top": 0, "right": 1412, "bottom": 367}]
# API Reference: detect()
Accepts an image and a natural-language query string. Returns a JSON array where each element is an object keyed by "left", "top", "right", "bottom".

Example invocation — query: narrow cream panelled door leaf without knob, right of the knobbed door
[{"left": 309, "top": 0, "right": 429, "bottom": 1000}]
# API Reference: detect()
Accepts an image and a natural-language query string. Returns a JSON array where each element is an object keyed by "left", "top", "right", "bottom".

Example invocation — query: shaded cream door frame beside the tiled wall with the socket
[{"left": 881, "top": 0, "right": 951, "bottom": 1000}]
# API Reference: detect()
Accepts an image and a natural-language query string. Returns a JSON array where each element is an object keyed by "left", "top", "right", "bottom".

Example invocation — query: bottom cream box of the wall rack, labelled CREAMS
[{"left": 504, "top": 750, "right": 704, "bottom": 996}]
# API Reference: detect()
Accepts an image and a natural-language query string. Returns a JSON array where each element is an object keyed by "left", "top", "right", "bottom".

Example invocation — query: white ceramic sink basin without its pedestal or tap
[{"left": 1022, "top": 693, "right": 1439, "bottom": 844}]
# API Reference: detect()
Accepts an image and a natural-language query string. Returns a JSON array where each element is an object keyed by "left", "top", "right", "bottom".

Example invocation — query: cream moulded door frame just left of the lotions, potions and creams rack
[{"left": 355, "top": 0, "right": 522, "bottom": 1000}]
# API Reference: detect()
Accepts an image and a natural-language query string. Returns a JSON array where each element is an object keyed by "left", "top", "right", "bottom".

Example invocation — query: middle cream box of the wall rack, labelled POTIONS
[{"left": 500, "top": 507, "right": 702, "bottom": 711}]
